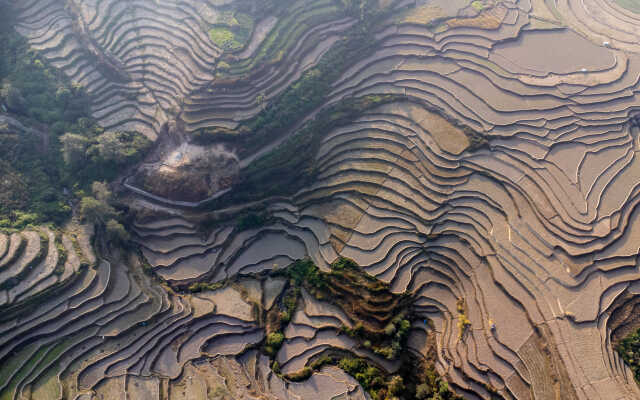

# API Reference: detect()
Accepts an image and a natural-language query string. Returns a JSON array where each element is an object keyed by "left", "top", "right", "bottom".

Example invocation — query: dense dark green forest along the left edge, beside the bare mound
[{"left": 0, "top": 5, "right": 151, "bottom": 228}]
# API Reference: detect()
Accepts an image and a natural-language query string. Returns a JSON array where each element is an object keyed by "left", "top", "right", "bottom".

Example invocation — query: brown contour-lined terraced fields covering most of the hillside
[{"left": 0, "top": 0, "right": 640, "bottom": 400}]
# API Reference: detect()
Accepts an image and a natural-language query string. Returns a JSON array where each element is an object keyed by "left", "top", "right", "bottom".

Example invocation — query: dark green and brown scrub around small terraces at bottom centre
[{"left": 264, "top": 258, "right": 460, "bottom": 400}]
